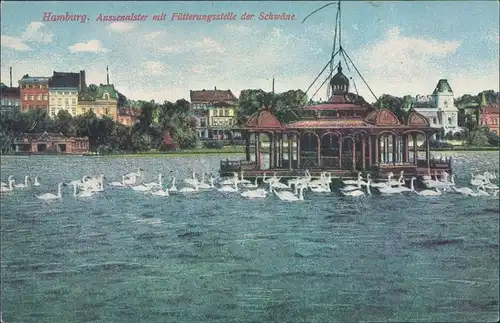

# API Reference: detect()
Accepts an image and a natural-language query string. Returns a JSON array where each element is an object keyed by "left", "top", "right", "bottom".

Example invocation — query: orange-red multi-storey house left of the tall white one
[{"left": 19, "top": 74, "right": 49, "bottom": 113}]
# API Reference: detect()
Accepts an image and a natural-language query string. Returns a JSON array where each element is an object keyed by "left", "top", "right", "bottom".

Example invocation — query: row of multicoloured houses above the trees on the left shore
[{"left": 0, "top": 71, "right": 139, "bottom": 125}]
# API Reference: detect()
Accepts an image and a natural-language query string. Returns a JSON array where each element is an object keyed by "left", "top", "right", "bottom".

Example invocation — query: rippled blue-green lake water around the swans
[{"left": 0, "top": 152, "right": 499, "bottom": 323}]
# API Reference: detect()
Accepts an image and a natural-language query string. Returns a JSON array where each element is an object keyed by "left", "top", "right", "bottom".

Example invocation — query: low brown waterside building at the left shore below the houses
[{"left": 13, "top": 132, "right": 90, "bottom": 154}]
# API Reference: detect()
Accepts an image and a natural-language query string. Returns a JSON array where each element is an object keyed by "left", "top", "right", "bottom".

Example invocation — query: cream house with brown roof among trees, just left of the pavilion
[{"left": 190, "top": 87, "right": 238, "bottom": 139}]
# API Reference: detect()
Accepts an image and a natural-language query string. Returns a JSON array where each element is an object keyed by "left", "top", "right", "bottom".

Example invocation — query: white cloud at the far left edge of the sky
[{"left": 1, "top": 21, "right": 54, "bottom": 51}]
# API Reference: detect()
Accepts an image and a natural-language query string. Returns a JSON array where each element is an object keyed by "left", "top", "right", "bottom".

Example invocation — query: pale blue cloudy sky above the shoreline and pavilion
[{"left": 1, "top": 1, "right": 500, "bottom": 102}]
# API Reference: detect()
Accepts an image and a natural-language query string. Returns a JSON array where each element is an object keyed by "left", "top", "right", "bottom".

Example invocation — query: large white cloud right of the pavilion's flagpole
[{"left": 349, "top": 27, "right": 461, "bottom": 100}]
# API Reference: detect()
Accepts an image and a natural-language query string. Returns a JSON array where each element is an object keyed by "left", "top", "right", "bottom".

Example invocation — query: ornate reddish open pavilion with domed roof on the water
[{"left": 220, "top": 63, "right": 451, "bottom": 178}]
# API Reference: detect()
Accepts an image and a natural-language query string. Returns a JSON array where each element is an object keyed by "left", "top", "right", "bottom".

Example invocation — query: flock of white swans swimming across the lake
[{"left": 0, "top": 168, "right": 499, "bottom": 201}]
